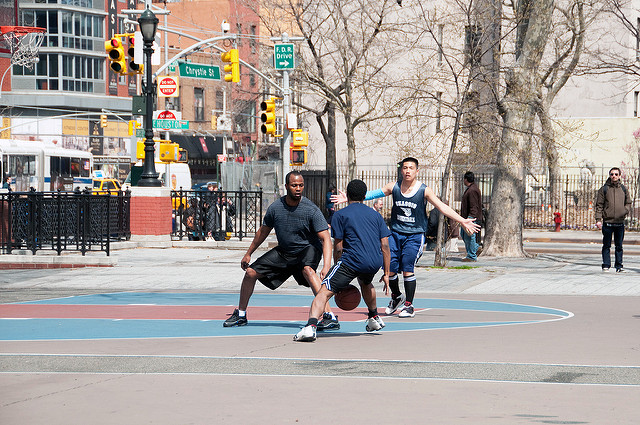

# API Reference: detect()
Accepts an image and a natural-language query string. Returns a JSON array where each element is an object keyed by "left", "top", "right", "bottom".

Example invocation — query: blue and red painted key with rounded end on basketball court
[{"left": 0, "top": 292, "right": 573, "bottom": 341}]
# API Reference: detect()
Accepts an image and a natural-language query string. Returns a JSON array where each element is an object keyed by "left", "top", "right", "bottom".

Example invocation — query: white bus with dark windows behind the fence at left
[{"left": 0, "top": 139, "right": 93, "bottom": 192}]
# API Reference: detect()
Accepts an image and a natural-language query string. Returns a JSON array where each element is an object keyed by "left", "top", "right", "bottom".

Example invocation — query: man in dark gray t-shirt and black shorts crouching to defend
[{"left": 223, "top": 171, "right": 339, "bottom": 328}]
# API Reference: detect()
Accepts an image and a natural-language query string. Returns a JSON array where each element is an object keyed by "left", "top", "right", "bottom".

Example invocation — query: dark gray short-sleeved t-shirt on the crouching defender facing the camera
[{"left": 262, "top": 196, "right": 328, "bottom": 254}]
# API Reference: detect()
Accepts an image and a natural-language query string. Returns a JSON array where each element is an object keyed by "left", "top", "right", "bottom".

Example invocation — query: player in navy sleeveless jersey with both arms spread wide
[{"left": 335, "top": 157, "right": 480, "bottom": 317}]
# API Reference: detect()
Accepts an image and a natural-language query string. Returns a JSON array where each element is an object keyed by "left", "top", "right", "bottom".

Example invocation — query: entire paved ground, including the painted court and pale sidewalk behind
[{"left": 0, "top": 231, "right": 640, "bottom": 425}]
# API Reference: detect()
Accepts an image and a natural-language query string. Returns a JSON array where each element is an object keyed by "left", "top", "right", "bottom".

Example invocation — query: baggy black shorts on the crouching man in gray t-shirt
[{"left": 249, "top": 245, "right": 322, "bottom": 289}]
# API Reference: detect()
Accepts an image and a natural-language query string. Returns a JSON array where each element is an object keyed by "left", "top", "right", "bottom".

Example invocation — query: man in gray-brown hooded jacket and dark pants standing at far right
[{"left": 595, "top": 167, "right": 631, "bottom": 272}]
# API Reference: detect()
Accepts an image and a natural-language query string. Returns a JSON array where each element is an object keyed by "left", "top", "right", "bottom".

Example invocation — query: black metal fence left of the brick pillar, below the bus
[{"left": 0, "top": 190, "right": 131, "bottom": 255}]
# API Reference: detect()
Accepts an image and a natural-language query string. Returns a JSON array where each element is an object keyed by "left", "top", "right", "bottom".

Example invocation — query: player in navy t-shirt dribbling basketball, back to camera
[{"left": 293, "top": 180, "right": 391, "bottom": 341}]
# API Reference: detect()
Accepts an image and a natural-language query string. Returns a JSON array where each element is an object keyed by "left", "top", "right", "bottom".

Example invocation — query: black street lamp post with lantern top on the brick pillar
[{"left": 138, "top": 8, "right": 162, "bottom": 187}]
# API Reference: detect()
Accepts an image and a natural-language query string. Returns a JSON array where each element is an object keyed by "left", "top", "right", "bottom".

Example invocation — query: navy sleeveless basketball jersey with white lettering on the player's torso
[{"left": 390, "top": 181, "right": 428, "bottom": 234}]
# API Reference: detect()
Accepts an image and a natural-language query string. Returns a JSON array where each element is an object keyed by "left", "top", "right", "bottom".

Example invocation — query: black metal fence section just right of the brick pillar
[{"left": 171, "top": 190, "right": 262, "bottom": 241}]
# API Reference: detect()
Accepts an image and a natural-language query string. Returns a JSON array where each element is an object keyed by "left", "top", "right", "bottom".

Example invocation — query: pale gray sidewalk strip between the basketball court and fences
[{"left": 0, "top": 232, "right": 640, "bottom": 296}]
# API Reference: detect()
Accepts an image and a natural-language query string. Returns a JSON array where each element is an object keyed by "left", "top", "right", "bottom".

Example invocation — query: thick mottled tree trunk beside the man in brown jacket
[{"left": 483, "top": 0, "right": 554, "bottom": 257}]
